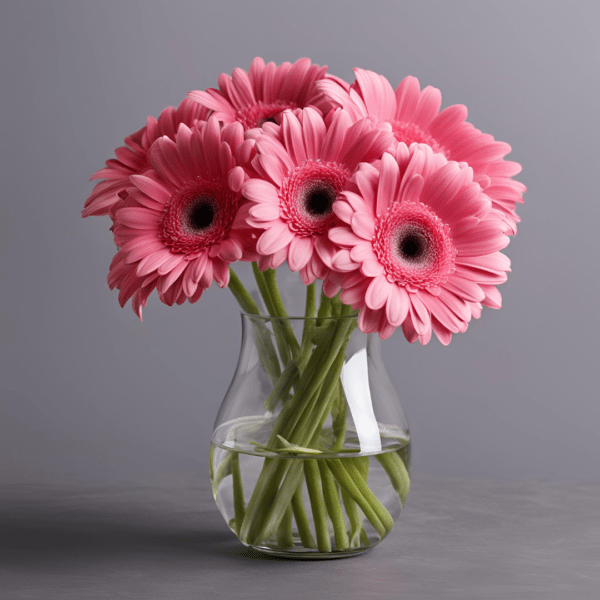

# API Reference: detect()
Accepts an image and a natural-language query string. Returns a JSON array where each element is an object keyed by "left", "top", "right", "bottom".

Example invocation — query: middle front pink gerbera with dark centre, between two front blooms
[{"left": 242, "top": 108, "right": 393, "bottom": 285}]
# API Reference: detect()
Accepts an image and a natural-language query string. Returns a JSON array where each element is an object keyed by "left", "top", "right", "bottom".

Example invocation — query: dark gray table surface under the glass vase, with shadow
[{"left": 0, "top": 471, "right": 600, "bottom": 600}]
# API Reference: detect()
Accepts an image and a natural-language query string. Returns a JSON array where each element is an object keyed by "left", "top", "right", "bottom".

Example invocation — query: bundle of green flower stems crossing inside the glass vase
[{"left": 212, "top": 263, "right": 410, "bottom": 552}]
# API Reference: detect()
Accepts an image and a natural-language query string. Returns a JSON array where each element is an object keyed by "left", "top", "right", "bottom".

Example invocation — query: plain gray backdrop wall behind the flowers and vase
[{"left": 0, "top": 0, "right": 600, "bottom": 484}]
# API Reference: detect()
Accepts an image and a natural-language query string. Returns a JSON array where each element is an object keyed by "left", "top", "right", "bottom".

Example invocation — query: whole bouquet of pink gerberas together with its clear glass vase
[{"left": 83, "top": 58, "right": 525, "bottom": 558}]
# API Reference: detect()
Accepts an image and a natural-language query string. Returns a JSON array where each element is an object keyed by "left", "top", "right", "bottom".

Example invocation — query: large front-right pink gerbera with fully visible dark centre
[{"left": 325, "top": 143, "right": 510, "bottom": 344}]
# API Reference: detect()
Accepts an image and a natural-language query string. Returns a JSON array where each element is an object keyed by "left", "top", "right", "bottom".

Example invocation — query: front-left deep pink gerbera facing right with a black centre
[{"left": 108, "top": 117, "right": 256, "bottom": 318}]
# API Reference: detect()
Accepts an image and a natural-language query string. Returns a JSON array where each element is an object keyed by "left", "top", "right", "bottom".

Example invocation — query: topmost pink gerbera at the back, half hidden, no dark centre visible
[{"left": 188, "top": 57, "right": 327, "bottom": 129}]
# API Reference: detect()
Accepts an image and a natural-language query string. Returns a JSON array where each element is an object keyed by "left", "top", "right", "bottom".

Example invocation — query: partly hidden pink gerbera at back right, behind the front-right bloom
[{"left": 317, "top": 69, "right": 527, "bottom": 234}]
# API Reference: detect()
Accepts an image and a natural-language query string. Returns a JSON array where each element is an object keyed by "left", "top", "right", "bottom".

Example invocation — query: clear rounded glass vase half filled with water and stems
[{"left": 210, "top": 310, "right": 410, "bottom": 559}]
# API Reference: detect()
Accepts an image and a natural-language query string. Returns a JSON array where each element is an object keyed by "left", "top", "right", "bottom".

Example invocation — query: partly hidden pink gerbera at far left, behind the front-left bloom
[{"left": 82, "top": 98, "right": 210, "bottom": 220}]
